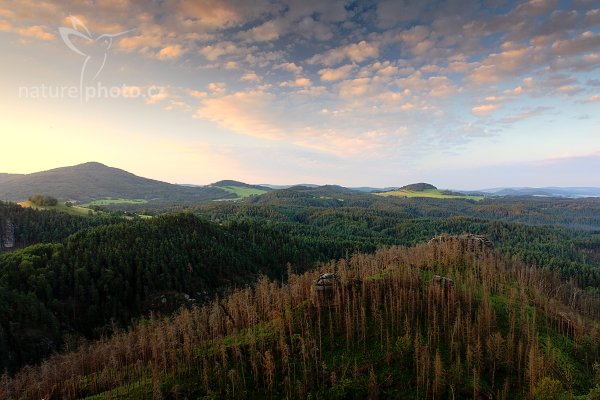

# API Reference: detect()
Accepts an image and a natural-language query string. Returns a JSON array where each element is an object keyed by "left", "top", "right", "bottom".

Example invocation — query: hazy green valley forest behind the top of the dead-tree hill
[{"left": 194, "top": 187, "right": 600, "bottom": 289}]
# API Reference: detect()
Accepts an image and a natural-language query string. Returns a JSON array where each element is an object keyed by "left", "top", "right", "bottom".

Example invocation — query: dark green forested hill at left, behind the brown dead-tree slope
[{"left": 0, "top": 214, "right": 316, "bottom": 370}]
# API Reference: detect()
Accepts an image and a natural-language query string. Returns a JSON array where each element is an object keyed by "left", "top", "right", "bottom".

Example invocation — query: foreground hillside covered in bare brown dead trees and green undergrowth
[{"left": 0, "top": 243, "right": 600, "bottom": 400}]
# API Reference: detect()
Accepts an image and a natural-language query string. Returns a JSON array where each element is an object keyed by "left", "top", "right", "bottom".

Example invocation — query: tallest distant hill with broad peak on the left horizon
[{"left": 0, "top": 162, "right": 235, "bottom": 204}]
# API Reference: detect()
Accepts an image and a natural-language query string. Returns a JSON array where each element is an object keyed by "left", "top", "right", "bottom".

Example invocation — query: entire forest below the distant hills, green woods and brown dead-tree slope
[{"left": 0, "top": 186, "right": 600, "bottom": 399}]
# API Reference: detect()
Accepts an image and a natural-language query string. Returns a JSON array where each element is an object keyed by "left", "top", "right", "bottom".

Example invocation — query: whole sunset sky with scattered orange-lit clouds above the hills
[{"left": 0, "top": 0, "right": 600, "bottom": 189}]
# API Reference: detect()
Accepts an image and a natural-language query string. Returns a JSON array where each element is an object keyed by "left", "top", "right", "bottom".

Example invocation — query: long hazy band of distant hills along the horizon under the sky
[{"left": 0, "top": 162, "right": 600, "bottom": 205}]
